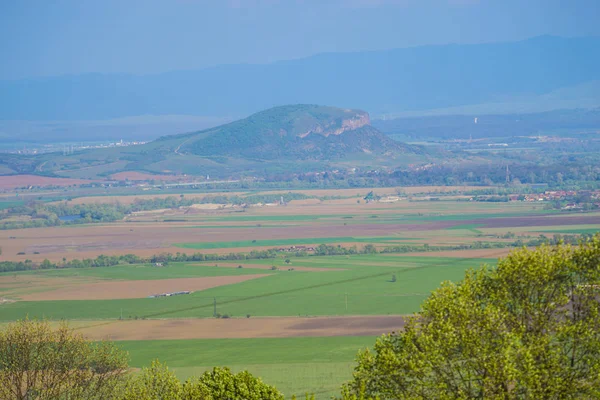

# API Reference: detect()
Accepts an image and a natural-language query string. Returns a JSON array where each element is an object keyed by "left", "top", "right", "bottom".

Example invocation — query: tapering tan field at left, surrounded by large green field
[{"left": 21, "top": 274, "right": 268, "bottom": 301}]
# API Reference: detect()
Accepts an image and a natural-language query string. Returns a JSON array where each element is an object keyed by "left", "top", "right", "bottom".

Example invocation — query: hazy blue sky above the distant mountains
[{"left": 0, "top": 0, "right": 600, "bottom": 79}]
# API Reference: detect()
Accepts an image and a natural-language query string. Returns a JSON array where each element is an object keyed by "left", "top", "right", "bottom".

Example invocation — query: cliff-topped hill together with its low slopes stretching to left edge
[{"left": 0, "top": 104, "right": 427, "bottom": 178}]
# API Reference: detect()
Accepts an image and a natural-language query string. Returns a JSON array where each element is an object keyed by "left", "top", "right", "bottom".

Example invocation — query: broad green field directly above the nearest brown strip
[{"left": 0, "top": 255, "right": 487, "bottom": 321}]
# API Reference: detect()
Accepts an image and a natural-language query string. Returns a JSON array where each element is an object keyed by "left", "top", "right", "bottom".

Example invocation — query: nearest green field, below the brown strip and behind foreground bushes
[{"left": 119, "top": 336, "right": 375, "bottom": 399}]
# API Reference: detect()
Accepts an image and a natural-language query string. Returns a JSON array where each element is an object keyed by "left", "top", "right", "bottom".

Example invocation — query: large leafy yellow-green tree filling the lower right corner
[{"left": 342, "top": 236, "right": 600, "bottom": 400}]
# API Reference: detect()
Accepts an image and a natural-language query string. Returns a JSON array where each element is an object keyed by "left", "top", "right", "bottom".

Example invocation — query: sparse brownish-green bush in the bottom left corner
[{"left": 0, "top": 319, "right": 128, "bottom": 400}]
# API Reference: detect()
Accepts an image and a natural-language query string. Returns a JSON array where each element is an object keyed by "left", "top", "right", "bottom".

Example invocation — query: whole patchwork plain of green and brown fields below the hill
[{"left": 0, "top": 188, "right": 600, "bottom": 399}]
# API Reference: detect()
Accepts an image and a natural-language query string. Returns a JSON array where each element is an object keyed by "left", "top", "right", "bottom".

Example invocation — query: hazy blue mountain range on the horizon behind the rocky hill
[{"left": 0, "top": 36, "right": 600, "bottom": 126}]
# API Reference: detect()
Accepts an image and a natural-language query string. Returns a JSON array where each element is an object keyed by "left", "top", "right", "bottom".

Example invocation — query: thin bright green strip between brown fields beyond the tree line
[{"left": 174, "top": 236, "right": 417, "bottom": 249}]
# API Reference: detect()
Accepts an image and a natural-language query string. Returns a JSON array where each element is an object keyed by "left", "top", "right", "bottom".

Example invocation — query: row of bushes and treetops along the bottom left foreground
[{"left": 0, "top": 320, "right": 284, "bottom": 400}]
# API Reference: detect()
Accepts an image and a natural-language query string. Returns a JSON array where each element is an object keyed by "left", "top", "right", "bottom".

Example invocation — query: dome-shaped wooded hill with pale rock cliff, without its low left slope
[{"left": 159, "top": 105, "right": 414, "bottom": 161}]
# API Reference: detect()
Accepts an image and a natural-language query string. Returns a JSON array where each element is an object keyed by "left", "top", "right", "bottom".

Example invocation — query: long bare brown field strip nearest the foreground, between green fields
[{"left": 77, "top": 315, "right": 404, "bottom": 340}]
